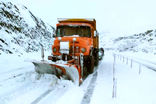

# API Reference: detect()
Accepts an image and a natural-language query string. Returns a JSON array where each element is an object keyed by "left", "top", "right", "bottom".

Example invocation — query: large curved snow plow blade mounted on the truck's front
[{"left": 32, "top": 61, "right": 80, "bottom": 84}]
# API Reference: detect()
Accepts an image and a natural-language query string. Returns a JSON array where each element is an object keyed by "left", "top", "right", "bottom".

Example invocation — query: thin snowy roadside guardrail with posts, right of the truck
[{"left": 112, "top": 53, "right": 156, "bottom": 98}]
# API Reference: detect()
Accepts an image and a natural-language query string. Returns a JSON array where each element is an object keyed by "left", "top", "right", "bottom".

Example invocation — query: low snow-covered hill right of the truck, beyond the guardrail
[{"left": 101, "top": 30, "right": 156, "bottom": 54}]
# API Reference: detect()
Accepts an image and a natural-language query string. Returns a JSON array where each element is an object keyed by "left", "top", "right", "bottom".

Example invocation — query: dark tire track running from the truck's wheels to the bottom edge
[{"left": 81, "top": 71, "right": 97, "bottom": 104}]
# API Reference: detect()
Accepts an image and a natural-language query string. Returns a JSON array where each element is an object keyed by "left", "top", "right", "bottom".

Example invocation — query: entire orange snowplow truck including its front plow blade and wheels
[{"left": 33, "top": 19, "right": 104, "bottom": 84}]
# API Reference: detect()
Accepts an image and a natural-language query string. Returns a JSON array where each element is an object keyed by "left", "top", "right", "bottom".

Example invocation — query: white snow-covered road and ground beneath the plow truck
[{"left": 0, "top": 52, "right": 156, "bottom": 104}]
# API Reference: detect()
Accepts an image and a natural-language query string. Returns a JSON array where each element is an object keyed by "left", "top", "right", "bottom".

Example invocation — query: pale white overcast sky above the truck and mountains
[{"left": 19, "top": 0, "right": 156, "bottom": 35}]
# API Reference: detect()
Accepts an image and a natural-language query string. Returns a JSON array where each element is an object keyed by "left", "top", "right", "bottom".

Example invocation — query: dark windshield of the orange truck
[{"left": 56, "top": 26, "right": 91, "bottom": 37}]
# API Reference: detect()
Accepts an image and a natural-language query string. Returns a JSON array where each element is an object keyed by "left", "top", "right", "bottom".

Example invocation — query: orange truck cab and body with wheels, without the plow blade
[{"left": 48, "top": 19, "right": 102, "bottom": 75}]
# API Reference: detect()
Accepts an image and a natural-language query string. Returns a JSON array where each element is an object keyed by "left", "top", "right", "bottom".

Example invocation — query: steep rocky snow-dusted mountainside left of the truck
[{"left": 0, "top": 1, "right": 54, "bottom": 54}]
